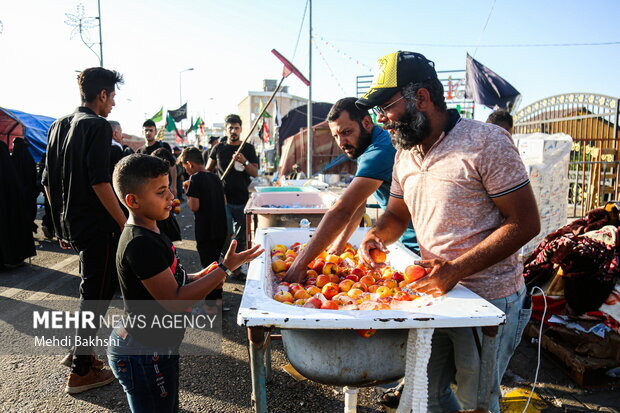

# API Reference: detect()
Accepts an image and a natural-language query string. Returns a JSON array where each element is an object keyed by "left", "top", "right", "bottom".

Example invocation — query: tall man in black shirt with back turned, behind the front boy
[{"left": 42, "top": 67, "right": 125, "bottom": 394}]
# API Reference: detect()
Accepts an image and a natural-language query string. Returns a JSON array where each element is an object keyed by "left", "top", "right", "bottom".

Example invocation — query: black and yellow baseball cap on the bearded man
[{"left": 355, "top": 51, "right": 437, "bottom": 110}]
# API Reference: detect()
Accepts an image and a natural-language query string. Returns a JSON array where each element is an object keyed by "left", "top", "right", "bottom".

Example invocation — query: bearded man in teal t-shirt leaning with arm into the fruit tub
[{"left": 285, "top": 98, "right": 418, "bottom": 282}]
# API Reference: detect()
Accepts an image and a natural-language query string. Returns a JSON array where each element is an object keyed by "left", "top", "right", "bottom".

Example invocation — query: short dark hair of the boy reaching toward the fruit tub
[{"left": 112, "top": 153, "right": 168, "bottom": 204}]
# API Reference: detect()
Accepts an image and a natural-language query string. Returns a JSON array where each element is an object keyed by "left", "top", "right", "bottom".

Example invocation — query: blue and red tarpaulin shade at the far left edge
[{"left": 0, "top": 108, "right": 55, "bottom": 162}]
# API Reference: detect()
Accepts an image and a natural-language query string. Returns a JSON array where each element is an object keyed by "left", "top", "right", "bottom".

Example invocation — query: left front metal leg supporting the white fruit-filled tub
[{"left": 248, "top": 327, "right": 267, "bottom": 413}]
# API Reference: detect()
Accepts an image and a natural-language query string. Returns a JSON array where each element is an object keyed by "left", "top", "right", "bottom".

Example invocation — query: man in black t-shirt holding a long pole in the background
[{"left": 207, "top": 115, "right": 258, "bottom": 260}]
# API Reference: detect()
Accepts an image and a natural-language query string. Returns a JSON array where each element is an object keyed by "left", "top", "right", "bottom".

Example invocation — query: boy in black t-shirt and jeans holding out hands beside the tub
[{"left": 108, "top": 154, "right": 263, "bottom": 412}]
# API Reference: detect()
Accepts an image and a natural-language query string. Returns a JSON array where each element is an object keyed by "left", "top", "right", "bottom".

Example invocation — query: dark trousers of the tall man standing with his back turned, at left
[{"left": 72, "top": 232, "right": 119, "bottom": 375}]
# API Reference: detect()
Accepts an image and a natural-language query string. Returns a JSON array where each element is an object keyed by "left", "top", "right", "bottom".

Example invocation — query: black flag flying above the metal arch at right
[{"left": 465, "top": 54, "right": 521, "bottom": 111}]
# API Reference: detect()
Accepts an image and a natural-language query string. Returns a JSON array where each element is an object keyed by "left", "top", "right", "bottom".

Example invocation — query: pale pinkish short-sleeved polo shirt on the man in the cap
[{"left": 390, "top": 119, "right": 529, "bottom": 300}]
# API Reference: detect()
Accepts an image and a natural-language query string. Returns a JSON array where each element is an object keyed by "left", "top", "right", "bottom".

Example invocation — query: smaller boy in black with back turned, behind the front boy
[{"left": 178, "top": 148, "right": 228, "bottom": 304}]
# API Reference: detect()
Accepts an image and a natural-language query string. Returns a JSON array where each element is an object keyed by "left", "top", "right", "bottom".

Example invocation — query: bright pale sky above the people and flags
[{"left": 0, "top": 0, "right": 620, "bottom": 134}]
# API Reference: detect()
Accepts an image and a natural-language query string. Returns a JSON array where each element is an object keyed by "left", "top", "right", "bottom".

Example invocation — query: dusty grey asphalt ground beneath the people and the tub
[{"left": 0, "top": 205, "right": 620, "bottom": 413}]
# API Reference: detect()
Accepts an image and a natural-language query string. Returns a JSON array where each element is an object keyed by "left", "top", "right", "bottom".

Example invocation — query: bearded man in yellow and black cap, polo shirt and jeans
[{"left": 356, "top": 52, "right": 540, "bottom": 412}]
